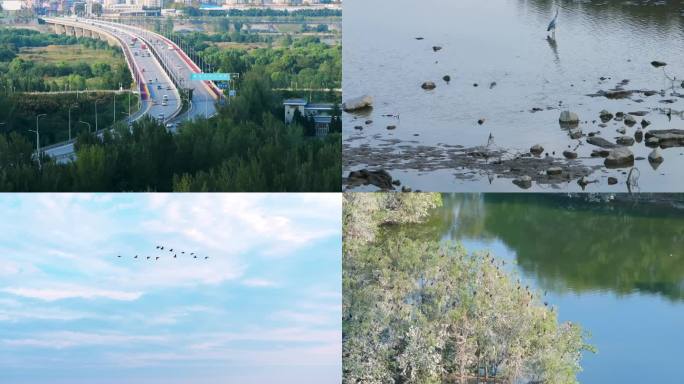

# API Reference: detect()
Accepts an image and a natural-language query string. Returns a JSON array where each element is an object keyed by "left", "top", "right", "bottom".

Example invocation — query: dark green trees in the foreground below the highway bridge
[{"left": 0, "top": 68, "right": 341, "bottom": 192}]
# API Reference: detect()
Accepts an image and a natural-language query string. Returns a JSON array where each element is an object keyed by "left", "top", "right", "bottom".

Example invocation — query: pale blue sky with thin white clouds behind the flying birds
[{"left": 0, "top": 194, "right": 342, "bottom": 384}]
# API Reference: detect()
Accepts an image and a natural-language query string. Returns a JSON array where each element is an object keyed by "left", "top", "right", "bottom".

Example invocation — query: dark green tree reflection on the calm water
[{"left": 420, "top": 195, "right": 684, "bottom": 300}]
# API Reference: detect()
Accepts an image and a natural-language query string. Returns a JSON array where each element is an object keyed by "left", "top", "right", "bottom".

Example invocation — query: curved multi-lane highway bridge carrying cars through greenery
[{"left": 41, "top": 17, "right": 222, "bottom": 162}]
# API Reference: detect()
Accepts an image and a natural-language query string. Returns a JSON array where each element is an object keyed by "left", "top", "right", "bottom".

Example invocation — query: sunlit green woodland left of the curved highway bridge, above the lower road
[{"left": 0, "top": 29, "right": 132, "bottom": 93}]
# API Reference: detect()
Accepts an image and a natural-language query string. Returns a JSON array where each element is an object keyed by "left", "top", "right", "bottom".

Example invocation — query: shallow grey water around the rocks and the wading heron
[{"left": 343, "top": 0, "right": 684, "bottom": 192}]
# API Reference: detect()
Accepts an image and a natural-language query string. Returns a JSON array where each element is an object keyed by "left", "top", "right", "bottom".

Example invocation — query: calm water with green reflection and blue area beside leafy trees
[{"left": 390, "top": 194, "right": 684, "bottom": 384}]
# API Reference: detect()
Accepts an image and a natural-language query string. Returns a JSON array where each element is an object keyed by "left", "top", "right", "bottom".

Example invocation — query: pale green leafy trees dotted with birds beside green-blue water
[{"left": 343, "top": 193, "right": 592, "bottom": 384}]
